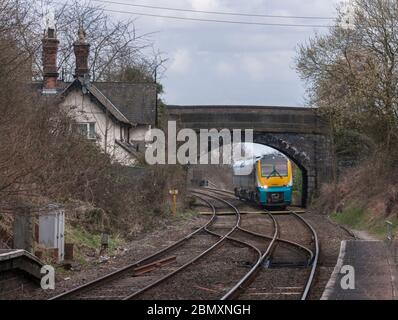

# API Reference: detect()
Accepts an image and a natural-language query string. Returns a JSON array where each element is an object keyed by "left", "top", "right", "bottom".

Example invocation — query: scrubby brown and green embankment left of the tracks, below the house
[{"left": 0, "top": 167, "right": 191, "bottom": 271}]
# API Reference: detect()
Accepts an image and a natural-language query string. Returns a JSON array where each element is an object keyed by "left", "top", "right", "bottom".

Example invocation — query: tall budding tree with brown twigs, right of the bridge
[{"left": 297, "top": 0, "right": 398, "bottom": 150}]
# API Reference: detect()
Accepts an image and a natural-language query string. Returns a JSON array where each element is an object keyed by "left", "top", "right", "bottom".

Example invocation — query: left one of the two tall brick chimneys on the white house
[{"left": 42, "top": 28, "right": 59, "bottom": 94}]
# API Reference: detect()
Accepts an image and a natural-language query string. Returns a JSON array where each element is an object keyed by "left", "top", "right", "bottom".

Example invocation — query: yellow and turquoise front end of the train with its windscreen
[{"left": 256, "top": 154, "right": 293, "bottom": 207}]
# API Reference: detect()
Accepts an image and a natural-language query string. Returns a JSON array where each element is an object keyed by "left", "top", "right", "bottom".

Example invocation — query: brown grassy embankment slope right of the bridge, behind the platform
[{"left": 314, "top": 156, "right": 398, "bottom": 239}]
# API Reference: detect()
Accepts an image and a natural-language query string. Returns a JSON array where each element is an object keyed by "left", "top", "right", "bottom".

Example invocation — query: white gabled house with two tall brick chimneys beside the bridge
[{"left": 36, "top": 28, "right": 157, "bottom": 165}]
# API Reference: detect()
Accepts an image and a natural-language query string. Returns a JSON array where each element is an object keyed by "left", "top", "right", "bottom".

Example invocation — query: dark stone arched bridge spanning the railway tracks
[{"left": 167, "top": 105, "right": 332, "bottom": 205}]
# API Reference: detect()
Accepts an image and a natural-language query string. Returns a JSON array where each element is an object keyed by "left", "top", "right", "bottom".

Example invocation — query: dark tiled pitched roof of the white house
[{"left": 33, "top": 78, "right": 156, "bottom": 125}]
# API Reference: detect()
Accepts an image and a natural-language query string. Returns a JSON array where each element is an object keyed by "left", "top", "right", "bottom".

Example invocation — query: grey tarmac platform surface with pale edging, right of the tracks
[{"left": 321, "top": 240, "right": 398, "bottom": 300}]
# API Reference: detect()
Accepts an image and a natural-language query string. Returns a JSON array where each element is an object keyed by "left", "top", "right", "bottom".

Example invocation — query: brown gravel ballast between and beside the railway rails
[{"left": 8, "top": 191, "right": 352, "bottom": 300}]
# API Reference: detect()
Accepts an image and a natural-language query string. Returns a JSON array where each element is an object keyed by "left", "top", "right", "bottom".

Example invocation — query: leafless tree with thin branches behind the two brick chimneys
[{"left": 11, "top": 0, "right": 162, "bottom": 81}]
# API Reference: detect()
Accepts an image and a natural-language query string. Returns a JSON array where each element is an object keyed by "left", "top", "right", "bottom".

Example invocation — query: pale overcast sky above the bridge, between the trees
[{"left": 84, "top": 0, "right": 340, "bottom": 106}]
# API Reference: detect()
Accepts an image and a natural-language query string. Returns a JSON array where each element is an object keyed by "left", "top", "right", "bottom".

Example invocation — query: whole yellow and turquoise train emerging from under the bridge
[{"left": 233, "top": 153, "right": 293, "bottom": 208}]
